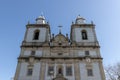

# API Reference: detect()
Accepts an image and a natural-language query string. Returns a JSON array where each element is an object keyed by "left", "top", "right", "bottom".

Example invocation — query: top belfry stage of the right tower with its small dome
[{"left": 71, "top": 15, "right": 98, "bottom": 44}]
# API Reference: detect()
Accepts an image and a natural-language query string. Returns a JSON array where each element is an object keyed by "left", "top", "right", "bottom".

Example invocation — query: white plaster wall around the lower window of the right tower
[{"left": 79, "top": 62, "right": 101, "bottom": 80}]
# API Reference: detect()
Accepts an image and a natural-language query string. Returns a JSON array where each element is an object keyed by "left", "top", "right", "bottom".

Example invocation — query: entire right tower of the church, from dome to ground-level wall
[{"left": 70, "top": 15, "right": 105, "bottom": 80}]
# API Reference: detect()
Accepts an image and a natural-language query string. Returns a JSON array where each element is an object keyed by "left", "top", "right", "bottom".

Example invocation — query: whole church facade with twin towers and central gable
[{"left": 14, "top": 16, "right": 105, "bottom": 80}]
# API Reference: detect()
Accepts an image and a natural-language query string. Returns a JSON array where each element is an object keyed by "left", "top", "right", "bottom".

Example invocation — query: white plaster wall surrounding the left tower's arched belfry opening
[{"left": 26, "top": 28, "right": 46, "bottom": 42}]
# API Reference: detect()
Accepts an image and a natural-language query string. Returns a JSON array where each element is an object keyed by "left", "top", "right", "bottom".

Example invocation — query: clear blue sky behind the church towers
[{"left": 0, "top": 0, "right": 120, "bottom": 80}]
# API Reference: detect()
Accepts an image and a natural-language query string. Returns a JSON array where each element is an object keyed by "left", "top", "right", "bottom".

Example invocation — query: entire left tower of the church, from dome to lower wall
[{"left": 14, "top": 15, "right": 51, "bottom": 80}]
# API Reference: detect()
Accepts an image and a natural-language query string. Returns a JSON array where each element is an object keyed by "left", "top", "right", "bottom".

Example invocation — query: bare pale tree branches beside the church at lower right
[{"left": 105, "top": 63, "right": 120, "bottom": 80}]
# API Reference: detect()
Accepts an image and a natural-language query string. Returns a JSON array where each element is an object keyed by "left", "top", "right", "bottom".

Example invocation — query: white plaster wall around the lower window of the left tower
[{"left": 18, "top": 63, "right": 41, "bottom": 80}]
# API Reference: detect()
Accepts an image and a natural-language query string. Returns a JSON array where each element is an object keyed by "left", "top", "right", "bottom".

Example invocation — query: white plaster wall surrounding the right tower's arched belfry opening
[{"left": 74, "top": 28, "right": 95, "bottom": 42}]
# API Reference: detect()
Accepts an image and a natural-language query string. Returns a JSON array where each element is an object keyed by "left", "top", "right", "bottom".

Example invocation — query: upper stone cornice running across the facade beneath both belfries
[{"left": 21, "top": 41, "right": 100, "bottom": 48}]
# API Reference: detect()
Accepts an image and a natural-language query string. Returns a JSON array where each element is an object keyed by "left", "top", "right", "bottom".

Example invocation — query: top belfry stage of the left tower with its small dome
[{"left": 23, "top": 16, "right": 50, "bottom": 43}]
